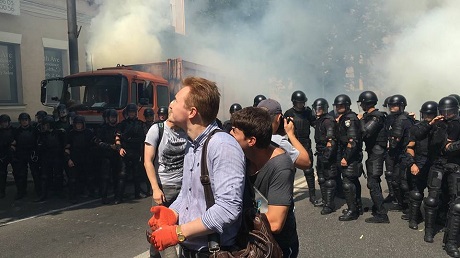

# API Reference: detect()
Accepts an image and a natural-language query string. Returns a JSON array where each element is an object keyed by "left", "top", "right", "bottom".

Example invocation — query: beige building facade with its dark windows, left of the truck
[{"left": 0, "top": 0, "right": 97, "bottom": 121}]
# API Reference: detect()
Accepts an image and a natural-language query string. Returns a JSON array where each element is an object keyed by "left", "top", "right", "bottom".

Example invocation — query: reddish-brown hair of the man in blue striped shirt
[{"left": 182, "top": 77, "right": 220, "bottom": 124}]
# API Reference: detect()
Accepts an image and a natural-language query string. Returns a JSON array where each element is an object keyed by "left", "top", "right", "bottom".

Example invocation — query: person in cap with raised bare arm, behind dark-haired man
[{"left": 257, "top": 98, "right": 311, "bottom": 169}]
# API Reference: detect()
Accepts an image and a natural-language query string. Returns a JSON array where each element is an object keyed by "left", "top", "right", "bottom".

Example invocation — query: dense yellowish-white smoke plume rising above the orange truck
[{"left": 87, "top": 0, "right": 171, "bottom": 69}]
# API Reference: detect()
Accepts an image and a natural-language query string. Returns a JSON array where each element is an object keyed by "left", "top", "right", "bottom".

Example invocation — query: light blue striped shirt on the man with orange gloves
[{"left": 170, "top": 122, "right": 246, "bottom": 250}]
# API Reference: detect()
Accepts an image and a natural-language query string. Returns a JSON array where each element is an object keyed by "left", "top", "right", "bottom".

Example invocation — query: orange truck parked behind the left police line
[{"left": 41, "top": 58, "right": 223, "bottom": 126}]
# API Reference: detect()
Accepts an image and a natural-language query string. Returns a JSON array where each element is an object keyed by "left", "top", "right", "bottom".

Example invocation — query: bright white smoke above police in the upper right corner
[{"left": 379, "top": 0, "right": 460, "bottom": 111}]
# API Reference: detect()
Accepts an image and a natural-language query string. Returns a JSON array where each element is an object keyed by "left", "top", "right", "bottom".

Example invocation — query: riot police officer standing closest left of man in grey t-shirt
[{"left": 115, "top": 103, "right": 146, "bottom": 204}]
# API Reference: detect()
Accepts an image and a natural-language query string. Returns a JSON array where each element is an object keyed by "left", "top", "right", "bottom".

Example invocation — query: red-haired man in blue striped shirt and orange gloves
[{"left": 149, "top": 77, "right": 245, "bottom": 257}]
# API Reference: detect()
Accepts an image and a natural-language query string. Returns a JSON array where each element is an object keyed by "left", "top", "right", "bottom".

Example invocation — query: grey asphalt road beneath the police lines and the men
[{"left": 0, "top": 172, "right": 447, "bottom": 257}]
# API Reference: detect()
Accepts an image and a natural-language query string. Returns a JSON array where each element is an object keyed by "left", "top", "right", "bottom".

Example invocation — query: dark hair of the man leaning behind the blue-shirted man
[{"left": 230, "top": 107, "right": 272, "bottom": 149}]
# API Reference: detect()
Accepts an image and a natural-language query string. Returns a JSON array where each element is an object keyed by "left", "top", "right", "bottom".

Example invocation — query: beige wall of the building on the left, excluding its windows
[{"left": 0, "top": 0, "right": 97, "bottom": 121}]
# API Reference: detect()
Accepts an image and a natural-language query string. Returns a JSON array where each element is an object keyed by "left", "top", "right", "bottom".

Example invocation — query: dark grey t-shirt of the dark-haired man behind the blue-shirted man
[{"left": 250, "top": 153, "right": 298, "bottom": 254}]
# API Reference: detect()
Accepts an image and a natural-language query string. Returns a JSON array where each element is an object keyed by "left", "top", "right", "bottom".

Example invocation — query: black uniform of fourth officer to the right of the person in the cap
[{"left": 361, "top": 109, "right": 387, "bottom": 215}]
